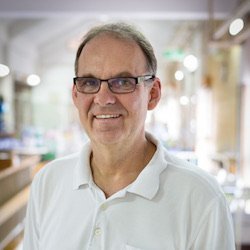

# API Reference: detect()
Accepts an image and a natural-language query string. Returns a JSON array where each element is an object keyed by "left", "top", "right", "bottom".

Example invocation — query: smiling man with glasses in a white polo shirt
[{"left": 24, "top": 23, "right": 235, "bottom": 250}]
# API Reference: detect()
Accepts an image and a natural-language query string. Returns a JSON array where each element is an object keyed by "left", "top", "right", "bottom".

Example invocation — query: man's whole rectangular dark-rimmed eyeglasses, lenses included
[{"left": 73, "top": 75, "right": 155, "bottom": 94}]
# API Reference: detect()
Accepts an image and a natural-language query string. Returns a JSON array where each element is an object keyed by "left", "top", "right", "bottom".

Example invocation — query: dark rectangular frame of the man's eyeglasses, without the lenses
[{"left": 73, "top": 75, "right": 155, "bottom": 94}]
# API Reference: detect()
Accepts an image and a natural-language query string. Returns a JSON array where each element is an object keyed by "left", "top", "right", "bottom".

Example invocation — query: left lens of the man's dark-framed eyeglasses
[{"left": 76, "top": 77, "right": 100, "bottom": 93}]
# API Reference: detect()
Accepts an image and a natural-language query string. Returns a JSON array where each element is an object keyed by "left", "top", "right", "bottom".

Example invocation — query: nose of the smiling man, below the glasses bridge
[{"left": 94, "top": 81, "right": 116, "bottom": 106}]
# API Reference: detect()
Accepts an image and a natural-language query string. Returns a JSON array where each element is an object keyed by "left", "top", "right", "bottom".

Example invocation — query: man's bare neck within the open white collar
[{"left": 91, "top": 138, "right": 155, "bottom": 197}]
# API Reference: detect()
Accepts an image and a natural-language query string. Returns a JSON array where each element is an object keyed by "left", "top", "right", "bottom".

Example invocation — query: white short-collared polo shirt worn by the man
[{"left": 24, "top": 135, "right": 235, "bottom": 250}]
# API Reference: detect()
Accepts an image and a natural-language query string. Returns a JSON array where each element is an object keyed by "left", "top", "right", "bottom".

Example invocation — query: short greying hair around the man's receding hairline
[{"left": 75, "top": 23, "right": 157, "bottom": 75}]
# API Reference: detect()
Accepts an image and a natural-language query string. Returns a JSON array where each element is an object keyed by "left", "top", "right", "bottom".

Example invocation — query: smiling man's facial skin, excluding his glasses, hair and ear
[{"left": 72, "top": 35, "right": 158, "bottom": 144}]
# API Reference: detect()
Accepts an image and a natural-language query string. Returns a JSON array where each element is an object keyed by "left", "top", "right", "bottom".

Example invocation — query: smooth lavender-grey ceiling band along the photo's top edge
[{"left": 0, "top": 0, "right": 239, "bottom": 19}]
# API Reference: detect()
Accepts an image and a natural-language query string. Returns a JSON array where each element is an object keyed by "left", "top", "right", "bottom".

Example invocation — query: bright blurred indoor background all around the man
[{"left": 0, "top": 0, "right": 250, "bottom": 249}]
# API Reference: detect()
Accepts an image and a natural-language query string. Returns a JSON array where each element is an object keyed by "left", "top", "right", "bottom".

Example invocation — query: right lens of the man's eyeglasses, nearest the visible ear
[{"left": 108, "top": 77, "right": 136, "bottom": 93}]
